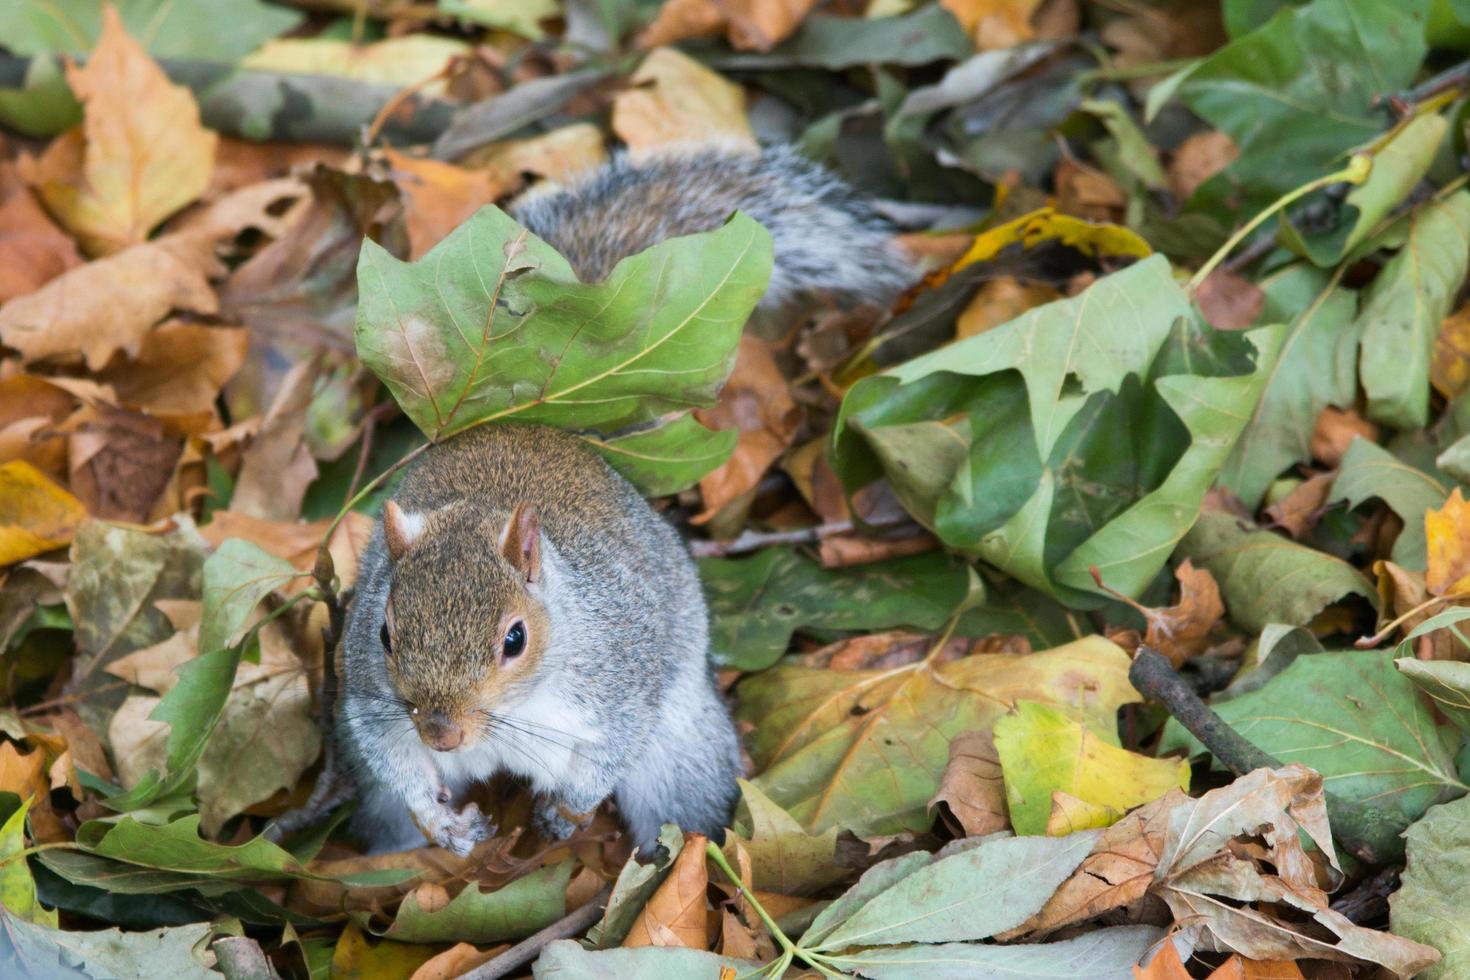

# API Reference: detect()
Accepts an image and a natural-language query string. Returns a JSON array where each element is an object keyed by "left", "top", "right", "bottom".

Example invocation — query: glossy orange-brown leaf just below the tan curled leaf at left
[{"left": 100, "top": 320, "right": 250, "bottom": 428}]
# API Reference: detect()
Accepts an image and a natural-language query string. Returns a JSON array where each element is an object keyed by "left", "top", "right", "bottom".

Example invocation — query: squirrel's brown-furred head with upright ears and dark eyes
[{"left": 379, "top": 501, "right": 550, "bottom": 752}]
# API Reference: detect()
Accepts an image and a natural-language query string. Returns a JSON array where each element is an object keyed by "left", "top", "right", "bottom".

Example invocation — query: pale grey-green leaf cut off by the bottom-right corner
[{"left": 1389, "top": 799, "right": 1470, "bottom": 980}]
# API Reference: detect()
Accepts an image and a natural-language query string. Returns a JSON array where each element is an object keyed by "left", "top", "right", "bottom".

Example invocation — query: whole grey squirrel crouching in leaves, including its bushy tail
[{"left": 335, "top": 145, "right": 917, "bottom": 854}]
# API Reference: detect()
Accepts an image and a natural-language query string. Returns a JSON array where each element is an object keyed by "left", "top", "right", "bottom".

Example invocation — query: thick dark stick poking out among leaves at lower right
[{"left": 1127, "top": 646, "right": 1404, "bottom": 864}]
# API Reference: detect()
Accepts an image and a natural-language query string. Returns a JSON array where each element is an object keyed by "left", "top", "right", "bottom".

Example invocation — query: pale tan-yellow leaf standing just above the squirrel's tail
[{"left": 613, "top": 47, "right": 759, "bottom": 154}]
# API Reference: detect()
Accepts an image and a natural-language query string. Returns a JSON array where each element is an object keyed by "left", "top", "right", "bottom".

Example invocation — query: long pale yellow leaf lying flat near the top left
[{"left": 241, "top": 34, "right": 470, "bottom": 94}]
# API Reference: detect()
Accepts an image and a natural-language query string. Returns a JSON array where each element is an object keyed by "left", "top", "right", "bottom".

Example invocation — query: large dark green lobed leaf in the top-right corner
[{"left": 1177, "top": 0, "right": 1429, "bottom": 215}]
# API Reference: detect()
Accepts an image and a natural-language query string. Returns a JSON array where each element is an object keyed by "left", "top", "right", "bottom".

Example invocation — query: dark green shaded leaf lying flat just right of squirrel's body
[{"left": 700, "top": 548, "right": 969, "bottom": 670}]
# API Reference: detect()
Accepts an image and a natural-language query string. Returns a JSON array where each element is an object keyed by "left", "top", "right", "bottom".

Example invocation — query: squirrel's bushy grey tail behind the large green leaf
[{"left": 512, "top": 144, "right": 919, "bottom": 310}]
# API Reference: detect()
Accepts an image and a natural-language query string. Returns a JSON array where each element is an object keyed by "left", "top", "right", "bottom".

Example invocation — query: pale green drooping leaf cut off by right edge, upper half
[{"left": 1358, "top": 193, "right": 1470, "bottom": 429}]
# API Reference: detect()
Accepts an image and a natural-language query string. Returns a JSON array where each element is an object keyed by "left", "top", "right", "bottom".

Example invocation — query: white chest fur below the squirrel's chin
[{"left": 434, "top": 683, "right": 601, "bottom": 792}]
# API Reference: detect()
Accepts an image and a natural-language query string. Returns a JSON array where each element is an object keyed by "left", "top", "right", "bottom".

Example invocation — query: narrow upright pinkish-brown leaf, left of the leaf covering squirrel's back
[{"left": 229, "top": 361, "right": 318, "bottom": 522}]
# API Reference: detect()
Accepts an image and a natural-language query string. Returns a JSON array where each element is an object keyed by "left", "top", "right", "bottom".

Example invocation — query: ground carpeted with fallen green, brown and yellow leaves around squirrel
[{"left": 0, "top": 0, "right": 1470, "bottom": 980}]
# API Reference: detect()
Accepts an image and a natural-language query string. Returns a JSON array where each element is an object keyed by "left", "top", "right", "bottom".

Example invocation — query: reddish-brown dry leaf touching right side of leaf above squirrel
[{"left": 692, "top": 334, "right": 801, "bottom": 525}]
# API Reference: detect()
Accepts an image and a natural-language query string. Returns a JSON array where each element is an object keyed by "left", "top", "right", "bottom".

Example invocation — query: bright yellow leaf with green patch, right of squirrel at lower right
[{"left": 995, "top": 701, "right": 1189, "bottom": 835}]
